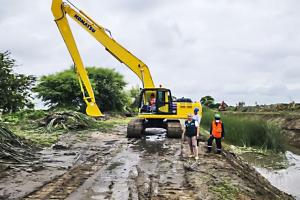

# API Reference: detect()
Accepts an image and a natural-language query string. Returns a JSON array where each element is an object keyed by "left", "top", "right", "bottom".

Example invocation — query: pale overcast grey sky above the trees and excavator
[{"left": 0, "top": 0, "right": 300, "bottom": 105}]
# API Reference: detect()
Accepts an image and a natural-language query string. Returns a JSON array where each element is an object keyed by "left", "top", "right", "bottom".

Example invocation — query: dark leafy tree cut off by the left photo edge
[{"left": 0, "top": 51, "right": 36, "bottom": 113}]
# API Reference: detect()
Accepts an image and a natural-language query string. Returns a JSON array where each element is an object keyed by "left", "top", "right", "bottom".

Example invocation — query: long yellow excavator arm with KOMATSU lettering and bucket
[{"left": 52, "top": 0, "right": 155, "bottom": 116}]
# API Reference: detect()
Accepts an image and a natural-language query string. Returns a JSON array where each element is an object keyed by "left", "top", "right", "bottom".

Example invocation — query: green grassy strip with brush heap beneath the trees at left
[{"left": 0, "top": 110, "right": 130, "bottom": 146}]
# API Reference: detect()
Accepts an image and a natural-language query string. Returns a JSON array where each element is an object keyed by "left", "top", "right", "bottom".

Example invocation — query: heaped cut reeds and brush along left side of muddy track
[{"left": 0, "top": 110, "right": 109, "bottom": 164}]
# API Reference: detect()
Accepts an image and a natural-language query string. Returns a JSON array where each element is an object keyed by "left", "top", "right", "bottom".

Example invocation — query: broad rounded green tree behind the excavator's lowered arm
[{"left": 34, "top": 67, "right": 128, "bottom": 111}]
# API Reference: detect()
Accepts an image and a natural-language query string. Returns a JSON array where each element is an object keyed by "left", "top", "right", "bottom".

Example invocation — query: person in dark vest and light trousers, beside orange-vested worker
[{"left": 182, "top": 114, "right": 199, "bottom": 160}]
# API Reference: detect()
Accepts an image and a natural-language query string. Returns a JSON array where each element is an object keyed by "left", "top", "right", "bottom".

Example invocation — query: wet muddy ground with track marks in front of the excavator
[{"left": 0, "top": 126, "right": 293, "bottom": 200}]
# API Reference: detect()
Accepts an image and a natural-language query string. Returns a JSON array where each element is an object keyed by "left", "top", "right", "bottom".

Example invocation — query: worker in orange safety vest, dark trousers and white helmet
[{"left": 207, "top": 114, "right": 225, "bottom": 154}]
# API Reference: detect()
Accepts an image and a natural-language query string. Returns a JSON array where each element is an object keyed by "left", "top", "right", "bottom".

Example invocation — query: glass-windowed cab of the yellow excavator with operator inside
[{"left": 140, "top": 88, "right": 176, "bottom": 114}]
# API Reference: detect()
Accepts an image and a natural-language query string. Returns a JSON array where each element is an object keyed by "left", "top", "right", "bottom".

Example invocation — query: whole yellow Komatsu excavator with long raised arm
[{"left": 52, "top": 0, "right": 202, "bottom": 138}]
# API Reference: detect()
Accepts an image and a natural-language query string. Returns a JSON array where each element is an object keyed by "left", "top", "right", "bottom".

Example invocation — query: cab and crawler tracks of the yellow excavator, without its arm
[{"left": 127, "top": 88, "right": 186, "bottom": 138}]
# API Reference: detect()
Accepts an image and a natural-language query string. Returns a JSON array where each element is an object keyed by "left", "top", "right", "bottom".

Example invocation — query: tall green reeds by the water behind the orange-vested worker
[{"left": 201, "top": 108, "right": 285, "bottom": 152}]
